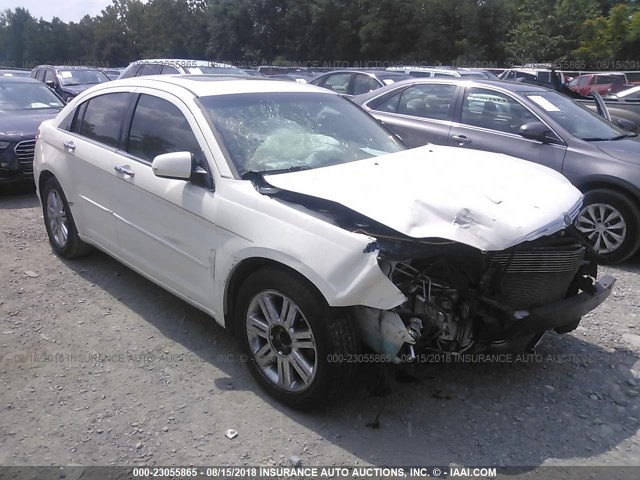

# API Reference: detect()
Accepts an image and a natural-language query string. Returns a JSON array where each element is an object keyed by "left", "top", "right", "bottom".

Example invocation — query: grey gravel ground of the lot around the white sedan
[{"left": 0, "top": 185, "right": 640, "bottom": 466}]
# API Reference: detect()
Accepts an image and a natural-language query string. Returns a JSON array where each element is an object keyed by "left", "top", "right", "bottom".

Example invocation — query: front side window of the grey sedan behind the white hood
[{"left": 462, "top": 88, "right": 538, "bottom": 134}]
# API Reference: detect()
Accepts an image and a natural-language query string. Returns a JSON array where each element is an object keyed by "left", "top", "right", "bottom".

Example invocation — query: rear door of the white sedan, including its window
[{"left": 53, "top": 92, "right": 133, "bottom": 255}]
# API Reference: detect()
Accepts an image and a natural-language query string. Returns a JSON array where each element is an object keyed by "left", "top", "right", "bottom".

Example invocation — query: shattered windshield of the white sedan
[{"left": 200, "top": 92, "right": 405, "bottom": 175}]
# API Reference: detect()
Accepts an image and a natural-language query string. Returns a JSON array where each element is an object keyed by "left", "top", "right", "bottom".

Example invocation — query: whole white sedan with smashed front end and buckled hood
[{"left": 34, "top": 76, "right": 615, "bottom": 407}]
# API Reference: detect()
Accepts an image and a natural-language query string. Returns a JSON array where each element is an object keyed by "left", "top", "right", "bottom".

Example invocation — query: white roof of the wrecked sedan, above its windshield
[{"left": 82, "top": 74, "right": 337, "bottom": 97}]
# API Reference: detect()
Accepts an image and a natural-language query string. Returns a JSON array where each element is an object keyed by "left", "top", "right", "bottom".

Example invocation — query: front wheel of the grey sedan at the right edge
[{"left": 576, "top": 189, "right": 640, "bottom": 264}]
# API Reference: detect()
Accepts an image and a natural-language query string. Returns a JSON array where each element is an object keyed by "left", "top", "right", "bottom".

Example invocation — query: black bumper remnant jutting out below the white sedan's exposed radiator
[{"left": 503, "top": 275, "right": 616, "bottom": 338}]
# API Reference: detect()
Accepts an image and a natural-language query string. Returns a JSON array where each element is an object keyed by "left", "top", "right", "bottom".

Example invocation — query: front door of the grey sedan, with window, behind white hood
[{"left": 449, "top": 87, "right": 567, "bottom": 172}]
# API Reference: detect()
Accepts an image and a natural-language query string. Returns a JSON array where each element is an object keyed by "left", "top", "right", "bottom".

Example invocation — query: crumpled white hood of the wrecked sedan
[{"left": 265, "top": 145, "right": 582, "bottom": 251}]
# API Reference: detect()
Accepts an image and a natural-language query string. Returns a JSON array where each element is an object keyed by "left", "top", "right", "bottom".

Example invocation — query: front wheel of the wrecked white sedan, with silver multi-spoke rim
[{"left": 235, "top": 268, "right": 360, "bottom": 409}]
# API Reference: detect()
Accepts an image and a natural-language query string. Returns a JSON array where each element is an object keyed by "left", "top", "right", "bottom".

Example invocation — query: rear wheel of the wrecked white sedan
[{"left": 41, "top": 177, "right": 92, "bottom": 258}]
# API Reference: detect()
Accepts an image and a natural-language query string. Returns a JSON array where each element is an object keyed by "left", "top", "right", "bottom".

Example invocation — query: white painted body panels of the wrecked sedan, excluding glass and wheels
[{"left": 34, "top": 76, "right": 580, "bottom": 334}]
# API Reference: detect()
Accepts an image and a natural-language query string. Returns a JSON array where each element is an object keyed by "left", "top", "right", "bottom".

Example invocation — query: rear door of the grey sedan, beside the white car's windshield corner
[{"left": 367, "top": 83, "right": 457, "bottom": 148}]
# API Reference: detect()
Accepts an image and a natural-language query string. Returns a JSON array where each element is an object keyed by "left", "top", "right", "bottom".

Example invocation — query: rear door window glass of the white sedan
[{"left": 79, "top": 93, "right": 132, "bottom": 148}]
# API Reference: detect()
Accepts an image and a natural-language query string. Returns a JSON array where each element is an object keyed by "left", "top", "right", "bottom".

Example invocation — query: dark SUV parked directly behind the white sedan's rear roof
[{"left": 31, "top": 65, "right": 110, "bottom": 102}]
